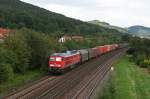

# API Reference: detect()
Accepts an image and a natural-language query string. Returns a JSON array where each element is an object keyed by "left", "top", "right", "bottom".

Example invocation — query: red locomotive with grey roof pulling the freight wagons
[{"left": 49, "top": 51, "right": 81, "bottom": 72}]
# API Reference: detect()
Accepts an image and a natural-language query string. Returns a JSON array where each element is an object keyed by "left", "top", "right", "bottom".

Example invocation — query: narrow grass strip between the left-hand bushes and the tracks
[{"left": 0, "top": 70, "right": 44, "bottom": 93}]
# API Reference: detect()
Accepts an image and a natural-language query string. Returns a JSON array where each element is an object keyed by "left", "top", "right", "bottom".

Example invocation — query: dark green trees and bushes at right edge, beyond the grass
[{"left": 128, "top": 37, "right": 150, "bottom": 70}]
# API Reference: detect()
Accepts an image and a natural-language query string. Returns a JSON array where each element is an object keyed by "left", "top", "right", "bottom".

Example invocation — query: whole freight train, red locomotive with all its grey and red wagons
[{"left": 48, "top": 44, "right": 125, "bottom": 73}]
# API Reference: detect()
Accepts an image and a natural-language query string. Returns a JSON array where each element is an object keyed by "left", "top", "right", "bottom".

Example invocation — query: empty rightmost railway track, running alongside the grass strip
[{"left": 72, "top": 48, "right": 126, "bottom": 99}]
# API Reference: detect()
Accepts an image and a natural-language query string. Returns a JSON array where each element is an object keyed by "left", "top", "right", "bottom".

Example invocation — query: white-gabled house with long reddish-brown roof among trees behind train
[{"left": 58, "top": 36, "right": 84, "bottom": 43}]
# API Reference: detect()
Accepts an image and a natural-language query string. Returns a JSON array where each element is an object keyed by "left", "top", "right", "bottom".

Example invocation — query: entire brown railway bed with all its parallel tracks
[{"left": 5, "top": 49, "right": 125, "bottom": 99}]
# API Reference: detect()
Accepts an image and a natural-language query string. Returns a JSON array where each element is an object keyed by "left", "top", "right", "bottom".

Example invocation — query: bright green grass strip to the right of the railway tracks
[{"left": 99, "top": 56, "right": 150, "bottom": 99}]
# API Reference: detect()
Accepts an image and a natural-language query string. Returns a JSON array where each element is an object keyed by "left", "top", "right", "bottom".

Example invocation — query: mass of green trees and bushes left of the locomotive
[{"left": 0, "top": 29, "right": 63, "bottom": 81}]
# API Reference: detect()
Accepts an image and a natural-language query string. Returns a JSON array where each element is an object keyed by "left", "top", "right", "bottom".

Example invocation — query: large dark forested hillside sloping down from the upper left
[{"left": 0, "top": 0, "right": 118, "bottom": 34}]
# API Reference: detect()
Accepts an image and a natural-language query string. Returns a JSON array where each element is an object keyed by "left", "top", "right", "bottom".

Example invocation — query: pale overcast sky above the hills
[{"left": 22, "top": 0, "right": 150, "bottom": 27}]
